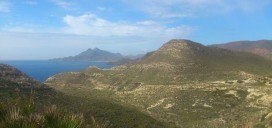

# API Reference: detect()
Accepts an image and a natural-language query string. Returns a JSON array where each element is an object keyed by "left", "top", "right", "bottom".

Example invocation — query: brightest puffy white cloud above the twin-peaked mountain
[{"left": 63, "top": 14, "right": 193, "bottom": 38}]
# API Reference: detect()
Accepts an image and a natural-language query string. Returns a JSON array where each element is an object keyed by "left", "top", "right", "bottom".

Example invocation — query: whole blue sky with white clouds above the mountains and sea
[{"left": 0, "top": 0, "right": 272, "bottom": 60}]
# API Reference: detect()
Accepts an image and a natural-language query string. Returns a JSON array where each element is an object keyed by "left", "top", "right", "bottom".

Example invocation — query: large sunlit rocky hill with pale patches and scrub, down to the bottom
[{"left": 46, "top": 40, "right": 272, "bottom": 128}]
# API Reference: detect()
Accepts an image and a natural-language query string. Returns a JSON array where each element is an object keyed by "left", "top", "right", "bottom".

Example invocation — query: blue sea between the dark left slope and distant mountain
[{"left": 0, "top": 60, "right": 114, "bottom": 82}]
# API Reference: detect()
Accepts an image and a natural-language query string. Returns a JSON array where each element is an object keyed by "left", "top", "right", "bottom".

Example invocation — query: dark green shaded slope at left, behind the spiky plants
[{"left": 0, "top": 64, "right": 167, "bottom": 128}]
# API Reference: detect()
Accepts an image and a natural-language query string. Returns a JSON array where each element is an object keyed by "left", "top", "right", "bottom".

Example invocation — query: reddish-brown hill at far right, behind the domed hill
[{"left": 211, "top": 40, "right": 272, "bottom": 58}]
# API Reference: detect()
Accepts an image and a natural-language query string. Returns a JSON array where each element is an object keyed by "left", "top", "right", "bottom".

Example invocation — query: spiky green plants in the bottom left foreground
[{"left": 0, "top": 97, "right": 109, "bottom": 128}]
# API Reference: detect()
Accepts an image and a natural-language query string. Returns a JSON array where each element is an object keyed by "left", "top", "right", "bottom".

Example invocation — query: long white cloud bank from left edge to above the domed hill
[{"left": 0, "top": 13, "right": 195, "bottom": 40}]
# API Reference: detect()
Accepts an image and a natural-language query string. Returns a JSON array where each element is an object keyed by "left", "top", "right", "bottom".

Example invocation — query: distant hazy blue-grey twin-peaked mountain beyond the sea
[{"left": 51, "top": 48, "right": 144, "bottom": 64}]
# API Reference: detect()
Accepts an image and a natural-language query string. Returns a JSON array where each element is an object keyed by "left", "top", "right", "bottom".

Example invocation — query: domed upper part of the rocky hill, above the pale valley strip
[{"left": 52, "top": 40, "right": 272, "bottom": 87}]
